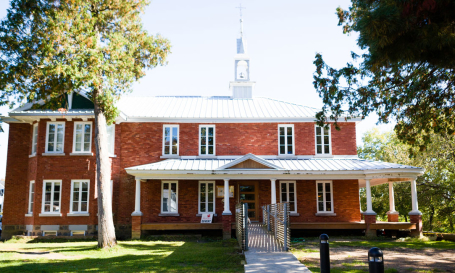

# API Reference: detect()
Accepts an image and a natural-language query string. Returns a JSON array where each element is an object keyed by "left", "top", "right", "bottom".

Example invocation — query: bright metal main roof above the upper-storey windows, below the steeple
[{"left": 117, "top": 96, "right": 319, "bottom": 119}]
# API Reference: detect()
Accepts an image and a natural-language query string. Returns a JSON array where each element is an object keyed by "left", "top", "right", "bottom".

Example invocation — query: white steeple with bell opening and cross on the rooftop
[{"left": 229, "top": 5, "right": 255, "bottom": 98}]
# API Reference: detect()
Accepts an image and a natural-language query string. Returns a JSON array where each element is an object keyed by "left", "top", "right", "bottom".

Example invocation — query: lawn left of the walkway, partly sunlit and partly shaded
[{"left": 0, "top": 235, "right": 244, "bottom": 272}]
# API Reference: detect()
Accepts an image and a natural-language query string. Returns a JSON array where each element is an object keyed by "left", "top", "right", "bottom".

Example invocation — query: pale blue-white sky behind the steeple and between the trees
[{"left": 0, "top": 0, "right": 392, "bottom": 178}]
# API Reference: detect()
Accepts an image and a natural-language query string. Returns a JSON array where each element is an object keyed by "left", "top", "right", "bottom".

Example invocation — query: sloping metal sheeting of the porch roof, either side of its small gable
[{"left": 126, "top": 158, "right": 422, "bottom": 171}]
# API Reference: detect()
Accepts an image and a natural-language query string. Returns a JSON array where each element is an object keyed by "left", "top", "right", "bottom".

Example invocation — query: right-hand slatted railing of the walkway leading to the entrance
[{"left": 262, "top": 203, "right": 291, "bottom": 251}]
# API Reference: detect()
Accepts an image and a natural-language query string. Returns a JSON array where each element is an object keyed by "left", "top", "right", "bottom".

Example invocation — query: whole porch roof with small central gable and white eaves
[{"left": 126, "top": 154, "right": 424, "bottom": 187}]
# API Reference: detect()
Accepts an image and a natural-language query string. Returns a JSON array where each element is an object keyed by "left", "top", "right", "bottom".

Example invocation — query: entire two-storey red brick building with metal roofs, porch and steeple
[{"left": 2, "top": 20, "right": 423, "bottom": 238}]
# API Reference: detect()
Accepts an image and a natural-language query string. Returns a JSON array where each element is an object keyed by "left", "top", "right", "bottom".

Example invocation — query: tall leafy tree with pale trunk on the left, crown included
[{"left": 0, "top": 0, "right": 170, "bottom": 248}]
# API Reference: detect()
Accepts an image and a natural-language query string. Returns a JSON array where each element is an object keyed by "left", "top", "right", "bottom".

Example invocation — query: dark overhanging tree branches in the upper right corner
[{"left": 313, "top": 0, "right": 455, "bottom": 150}]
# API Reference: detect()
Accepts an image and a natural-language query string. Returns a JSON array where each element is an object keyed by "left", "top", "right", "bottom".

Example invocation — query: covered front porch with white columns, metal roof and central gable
[{"left": 126, "top": 154, "right": 423, "bottom": 238}]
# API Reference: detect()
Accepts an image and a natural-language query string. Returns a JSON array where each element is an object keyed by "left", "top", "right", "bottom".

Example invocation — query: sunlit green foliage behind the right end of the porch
[{"left": 358, "top": 129, "right": 455, "bottom": 232}]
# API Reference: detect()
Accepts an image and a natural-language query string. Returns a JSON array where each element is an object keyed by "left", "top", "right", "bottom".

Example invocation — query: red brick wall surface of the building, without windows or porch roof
[{"left": 4, "top": 119, "right": 360, "bottom": 232}]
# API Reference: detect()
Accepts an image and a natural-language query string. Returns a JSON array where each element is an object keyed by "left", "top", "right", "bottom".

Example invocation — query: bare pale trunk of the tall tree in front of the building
[{"left": 93, "top": 92, "right": 117, "bottom": 248}]
